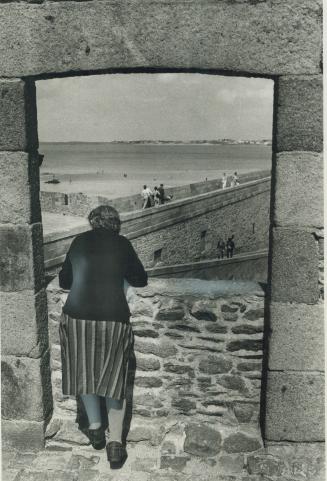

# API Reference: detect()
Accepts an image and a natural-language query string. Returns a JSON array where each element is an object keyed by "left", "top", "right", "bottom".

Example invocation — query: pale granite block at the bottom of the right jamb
[{"left": 265, "top": 371, "right": 325, "bottom": 442}]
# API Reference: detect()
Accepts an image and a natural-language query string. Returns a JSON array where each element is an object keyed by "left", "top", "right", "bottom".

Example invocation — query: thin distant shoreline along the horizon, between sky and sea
[{"left": 40, "top": 139, "right": 272, "bottom": 145}]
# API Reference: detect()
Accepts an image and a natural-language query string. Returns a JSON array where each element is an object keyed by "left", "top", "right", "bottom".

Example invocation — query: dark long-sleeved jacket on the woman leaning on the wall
[{"left": 59, "top": 228, "right": 148, "bottom": 322}]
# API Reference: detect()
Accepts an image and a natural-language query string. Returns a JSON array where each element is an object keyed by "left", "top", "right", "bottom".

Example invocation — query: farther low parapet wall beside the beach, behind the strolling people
[{"left": 40, "top": 168, "right": 271, "bottom": 217}]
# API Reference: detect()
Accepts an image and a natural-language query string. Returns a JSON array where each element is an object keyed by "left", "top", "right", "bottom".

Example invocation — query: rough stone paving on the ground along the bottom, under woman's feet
[{"left": 2, "top": 441, "right": 325, "bottom": 481}]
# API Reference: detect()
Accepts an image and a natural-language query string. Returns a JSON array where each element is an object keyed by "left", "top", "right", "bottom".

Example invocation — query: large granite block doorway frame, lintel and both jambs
[{"left": 0, "top": 0, "right": 324, "bottom": 462}]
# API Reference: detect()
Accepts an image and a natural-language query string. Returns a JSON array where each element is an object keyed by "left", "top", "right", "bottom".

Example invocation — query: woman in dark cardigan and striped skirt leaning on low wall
[{"left": 59, "top": 205, "right": 147, "bottom": 469}]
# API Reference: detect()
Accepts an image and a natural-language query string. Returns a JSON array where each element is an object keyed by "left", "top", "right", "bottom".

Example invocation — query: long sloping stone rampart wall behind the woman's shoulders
[{"left": 44, "top": 177, "right": 270, "bottom": 270}]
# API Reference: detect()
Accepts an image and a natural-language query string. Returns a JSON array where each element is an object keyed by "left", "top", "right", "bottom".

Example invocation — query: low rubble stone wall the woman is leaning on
[{"left": 48, "top": 279, "right": 264, "bottom": 474}]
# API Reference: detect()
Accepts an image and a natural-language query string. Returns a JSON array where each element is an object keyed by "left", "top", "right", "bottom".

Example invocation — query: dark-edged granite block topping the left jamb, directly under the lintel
[{"left": 0, "top": 79, "right": 38, "bottom": 151}]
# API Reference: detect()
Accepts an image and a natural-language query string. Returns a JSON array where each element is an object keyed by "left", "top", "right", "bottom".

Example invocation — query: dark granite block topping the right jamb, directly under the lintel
[{"left": 276, "top": 75, "right": 323, "bottom": 152}]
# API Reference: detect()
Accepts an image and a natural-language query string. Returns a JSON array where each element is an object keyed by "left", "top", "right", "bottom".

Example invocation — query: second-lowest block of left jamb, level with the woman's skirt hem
[{"left": 1, "top": 353, "right": 52, "bottom": 421}]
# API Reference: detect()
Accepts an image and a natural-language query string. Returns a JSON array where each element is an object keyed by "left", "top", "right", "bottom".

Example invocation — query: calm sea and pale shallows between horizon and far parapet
[{"left": 39, "top": 143, "right": 271, "bottom": 197}]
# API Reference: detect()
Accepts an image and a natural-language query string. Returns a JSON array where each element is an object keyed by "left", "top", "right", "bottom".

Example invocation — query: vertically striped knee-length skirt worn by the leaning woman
[{"left": 59, "top": 313, "right": 134, "bottom": 399}]
